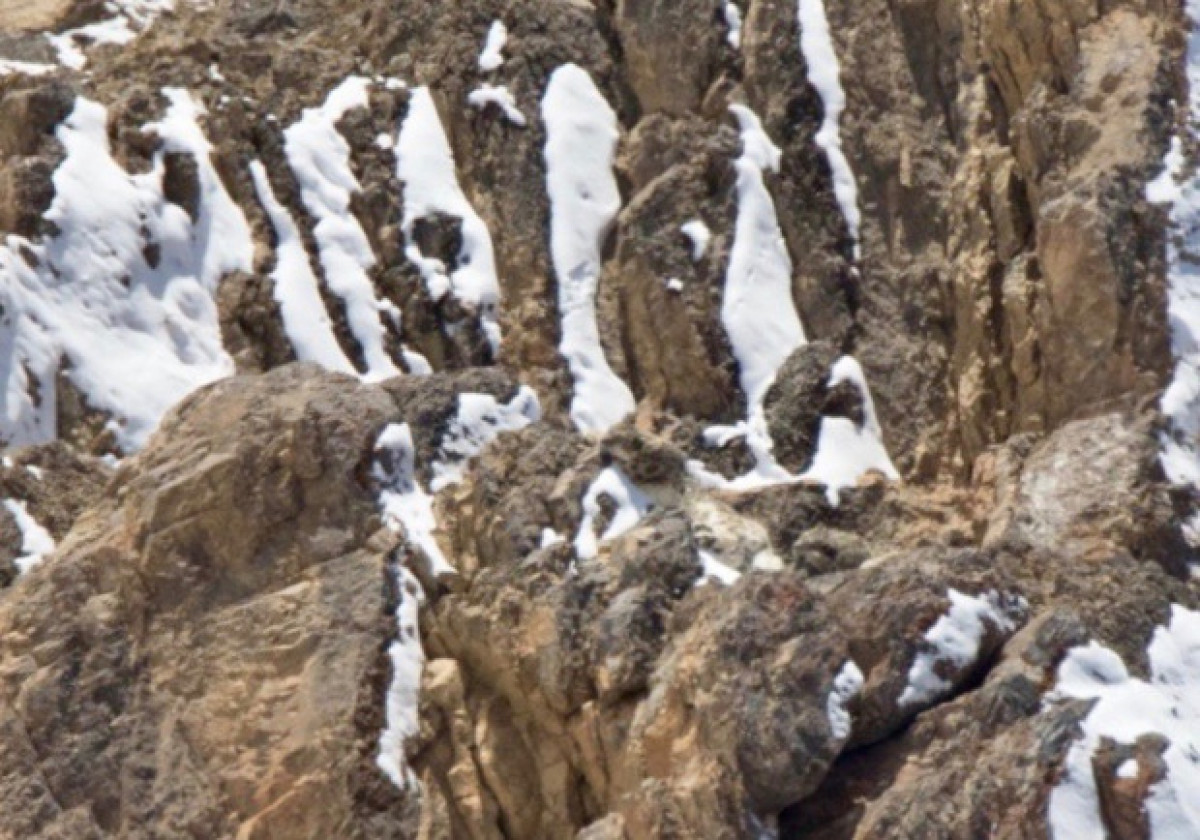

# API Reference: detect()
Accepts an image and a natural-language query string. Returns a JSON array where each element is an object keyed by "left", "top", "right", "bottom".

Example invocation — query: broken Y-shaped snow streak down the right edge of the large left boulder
[{"left": 372, "top": 388, "right": 541, "bottom": 790}]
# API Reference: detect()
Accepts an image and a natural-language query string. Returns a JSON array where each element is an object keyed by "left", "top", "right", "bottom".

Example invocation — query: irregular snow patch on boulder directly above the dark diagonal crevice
[{"left": 896, "top": 589, "right": 1026, "bottom": 707}]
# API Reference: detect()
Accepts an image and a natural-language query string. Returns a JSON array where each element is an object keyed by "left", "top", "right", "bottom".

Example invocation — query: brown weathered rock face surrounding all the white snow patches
[{"left": 0, "top": 0, "right": 1200, "bottom": 840}]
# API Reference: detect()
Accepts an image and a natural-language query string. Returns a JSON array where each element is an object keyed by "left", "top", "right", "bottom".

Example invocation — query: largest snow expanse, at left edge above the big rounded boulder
[{"left": 0, "top": 89, "right": 253, "bottom": 451}]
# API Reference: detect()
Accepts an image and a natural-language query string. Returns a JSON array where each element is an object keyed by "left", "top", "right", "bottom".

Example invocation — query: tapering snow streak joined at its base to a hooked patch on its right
[{"left": 689, "top": 106, "right": 900, "bottom": 504}]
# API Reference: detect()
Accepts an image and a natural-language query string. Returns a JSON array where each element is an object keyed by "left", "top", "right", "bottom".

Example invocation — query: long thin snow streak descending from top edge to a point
[{"left": 798, "top": 0, "right": 863, "bottom": 260}]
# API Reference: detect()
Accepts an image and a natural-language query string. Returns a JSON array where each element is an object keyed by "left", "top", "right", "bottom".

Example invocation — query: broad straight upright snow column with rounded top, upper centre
[{"left": 541, "top": 65, "right": 635, "bottom": 432}]
